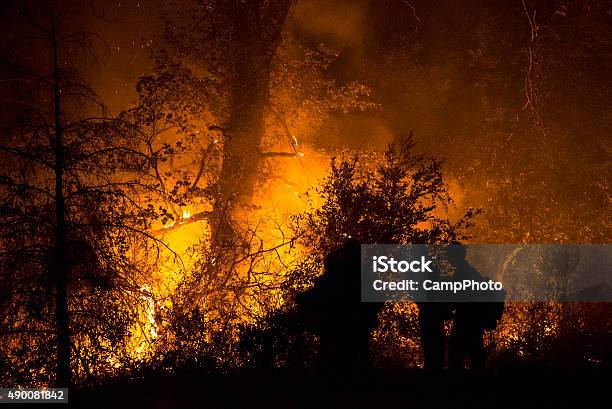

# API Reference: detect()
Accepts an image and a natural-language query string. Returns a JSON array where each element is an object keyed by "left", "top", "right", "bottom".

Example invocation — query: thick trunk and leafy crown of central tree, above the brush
[{"left": 132, "top": 0, "right": 373, "bottom": 242}]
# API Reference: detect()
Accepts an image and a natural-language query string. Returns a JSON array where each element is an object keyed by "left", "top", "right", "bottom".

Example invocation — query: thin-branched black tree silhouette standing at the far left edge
[{"left": 0, "top": 2, "right": 173, "bottom": 386}]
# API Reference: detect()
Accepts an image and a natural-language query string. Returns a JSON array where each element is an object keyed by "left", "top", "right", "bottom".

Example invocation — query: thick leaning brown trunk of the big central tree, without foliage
[{"left": 213, "top": 0, "right": 292, "bottom": 243}]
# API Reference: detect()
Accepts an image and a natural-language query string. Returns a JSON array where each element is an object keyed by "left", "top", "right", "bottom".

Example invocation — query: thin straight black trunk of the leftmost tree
[{"left": 51, "top": 21, "right": 71, "bottom": 387}]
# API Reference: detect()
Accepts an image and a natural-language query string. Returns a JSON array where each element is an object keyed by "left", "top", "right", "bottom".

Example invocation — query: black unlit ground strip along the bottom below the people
[{"left": 49, "top": 369, "right": 612, "bottom": 409}]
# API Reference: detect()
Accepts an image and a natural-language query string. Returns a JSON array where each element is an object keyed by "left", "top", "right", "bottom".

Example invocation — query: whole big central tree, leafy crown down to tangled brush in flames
[{"left": 124, "top": 1, "right": 375, "bottom": 364}]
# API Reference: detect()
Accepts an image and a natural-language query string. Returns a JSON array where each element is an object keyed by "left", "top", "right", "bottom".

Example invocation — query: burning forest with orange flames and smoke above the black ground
[{"left": 0, "top": 0, "right": 612, "bottom": 407}]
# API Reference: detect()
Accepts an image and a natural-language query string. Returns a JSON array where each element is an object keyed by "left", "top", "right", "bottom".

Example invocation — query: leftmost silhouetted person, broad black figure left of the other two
[{"left": 297, "top": 239, "right": 381, "bottom": 371}]
